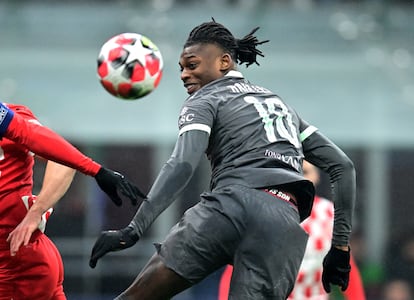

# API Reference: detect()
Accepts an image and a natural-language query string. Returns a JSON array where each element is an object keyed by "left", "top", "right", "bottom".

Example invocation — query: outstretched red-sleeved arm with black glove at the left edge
[{"left": 0, "top": 103, "right": 145, "bottom": 206}]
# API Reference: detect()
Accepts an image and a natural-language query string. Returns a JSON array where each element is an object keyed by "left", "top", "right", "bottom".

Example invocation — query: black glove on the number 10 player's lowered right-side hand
[{"left": 322, "top": 246, "right": 351, "bottom": 293}]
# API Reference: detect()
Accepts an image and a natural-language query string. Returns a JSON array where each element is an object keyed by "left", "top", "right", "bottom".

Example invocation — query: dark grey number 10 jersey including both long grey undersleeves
[{"left": 131, "top": 71, "right": 355, "bottom": 245}]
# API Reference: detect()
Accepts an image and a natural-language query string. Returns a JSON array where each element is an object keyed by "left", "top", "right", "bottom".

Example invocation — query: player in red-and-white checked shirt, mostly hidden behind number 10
[{"left": 218, "top": 161, "right": 365, "bottom": 300}]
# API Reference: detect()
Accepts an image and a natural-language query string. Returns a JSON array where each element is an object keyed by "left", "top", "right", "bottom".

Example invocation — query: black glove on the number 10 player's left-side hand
[{"left": 89, "top": 226, "right": 139, "bottom": 268}]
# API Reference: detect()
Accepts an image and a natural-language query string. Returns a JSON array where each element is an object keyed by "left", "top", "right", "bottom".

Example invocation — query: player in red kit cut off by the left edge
[{"left": 0, "top": 103, "right": 145, "bottom": 300}]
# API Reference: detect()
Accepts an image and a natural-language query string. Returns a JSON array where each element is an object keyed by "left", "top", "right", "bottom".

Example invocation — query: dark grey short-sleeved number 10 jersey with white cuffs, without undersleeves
[{"left": 178, "top": 71, "right": 316, "bottom": 188}]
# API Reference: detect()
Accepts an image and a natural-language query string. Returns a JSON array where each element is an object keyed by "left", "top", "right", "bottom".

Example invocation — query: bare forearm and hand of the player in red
[{"left": 7, "top": 161, "right": 76, "bottom": 256}]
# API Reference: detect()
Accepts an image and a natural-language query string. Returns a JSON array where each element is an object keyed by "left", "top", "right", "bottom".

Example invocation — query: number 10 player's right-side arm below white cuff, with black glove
[{"left": 302, "top": 126, "right": 356, "bottom": 293}]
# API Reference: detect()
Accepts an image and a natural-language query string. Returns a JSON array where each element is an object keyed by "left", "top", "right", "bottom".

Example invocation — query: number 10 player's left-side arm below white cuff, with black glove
[{"left": 89, "top": 130, "right": 209, "bottom": 268}]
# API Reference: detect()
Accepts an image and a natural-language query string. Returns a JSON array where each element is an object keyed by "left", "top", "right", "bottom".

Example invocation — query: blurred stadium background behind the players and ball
[{"left": 0, "top": 0, "right": 414, "bottom": 300}]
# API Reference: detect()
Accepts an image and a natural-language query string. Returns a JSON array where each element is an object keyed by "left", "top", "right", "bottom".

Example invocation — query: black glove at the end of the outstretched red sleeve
[{"left": 95, "top": 167, "right": 147, "bottom": 206}]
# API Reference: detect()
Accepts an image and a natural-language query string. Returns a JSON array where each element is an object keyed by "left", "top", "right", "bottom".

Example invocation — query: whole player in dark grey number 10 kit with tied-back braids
[{"left": 90, "top": 20, "right": 355, "bottom": 300}]
